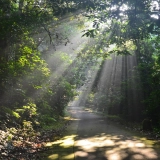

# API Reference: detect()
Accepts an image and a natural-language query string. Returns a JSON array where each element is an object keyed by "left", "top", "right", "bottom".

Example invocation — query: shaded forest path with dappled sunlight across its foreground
[{"left": 43, "top": 80, "right": 160, "bottom": 160}]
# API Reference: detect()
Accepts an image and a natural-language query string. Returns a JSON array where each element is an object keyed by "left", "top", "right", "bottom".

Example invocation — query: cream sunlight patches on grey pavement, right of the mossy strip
[{"left": 75, "top": 135, "right": 158, "bottom": 160}]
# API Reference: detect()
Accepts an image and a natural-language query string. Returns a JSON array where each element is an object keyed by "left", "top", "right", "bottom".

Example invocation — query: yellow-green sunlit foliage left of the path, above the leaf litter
[{"left": 0, "top": 0, "right": 86, "bottom": 132}]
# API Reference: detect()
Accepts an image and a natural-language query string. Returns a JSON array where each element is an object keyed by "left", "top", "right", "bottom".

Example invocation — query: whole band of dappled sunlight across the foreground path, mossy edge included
[{"left": 42, "top": 127, "right": 158, "bottom": 160}]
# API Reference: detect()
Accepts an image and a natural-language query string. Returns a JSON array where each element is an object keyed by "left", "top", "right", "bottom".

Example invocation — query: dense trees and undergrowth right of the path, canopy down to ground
[{"left": 85, "top": 0, "right": 160, "bottom": 128}]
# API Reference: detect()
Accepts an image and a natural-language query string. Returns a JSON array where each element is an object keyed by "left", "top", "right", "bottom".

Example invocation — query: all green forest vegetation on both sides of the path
[{"left": 0, "top": 0, "right": 160, "bottom": 158}]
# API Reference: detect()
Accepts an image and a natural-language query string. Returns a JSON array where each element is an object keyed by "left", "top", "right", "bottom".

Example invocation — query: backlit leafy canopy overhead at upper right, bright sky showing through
[{"left": 83, "top": 0, "right": 160, "bottom": 53}]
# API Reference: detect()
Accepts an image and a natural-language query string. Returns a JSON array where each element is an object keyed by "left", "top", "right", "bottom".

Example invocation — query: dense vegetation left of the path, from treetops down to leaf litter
[{"left": 0, "top": 0, "right": 99, "bottom": 159}]
